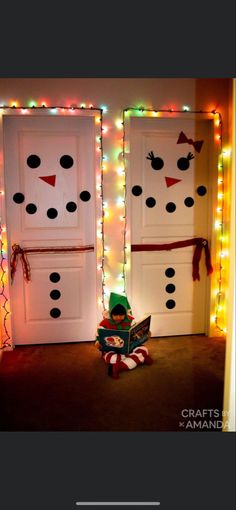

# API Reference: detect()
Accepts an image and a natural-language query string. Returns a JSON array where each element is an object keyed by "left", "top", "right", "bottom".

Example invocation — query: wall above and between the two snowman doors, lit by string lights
[{"left": 0, "top": 78, "right": 232, "bottom": 344}]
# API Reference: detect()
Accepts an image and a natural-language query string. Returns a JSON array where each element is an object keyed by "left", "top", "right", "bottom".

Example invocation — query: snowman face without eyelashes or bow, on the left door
[{"left": 12, "top": 133, "right": 91, "bottom": 228}]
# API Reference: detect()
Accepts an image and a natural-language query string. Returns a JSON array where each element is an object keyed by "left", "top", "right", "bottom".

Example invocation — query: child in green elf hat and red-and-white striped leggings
[{"left": 95, "top": 292, "right": 153, "bottom": 379}]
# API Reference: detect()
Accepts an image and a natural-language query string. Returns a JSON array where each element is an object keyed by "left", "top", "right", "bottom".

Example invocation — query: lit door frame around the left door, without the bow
[{"left": 0, "top": 105, "right": 104, "bottom": 350}]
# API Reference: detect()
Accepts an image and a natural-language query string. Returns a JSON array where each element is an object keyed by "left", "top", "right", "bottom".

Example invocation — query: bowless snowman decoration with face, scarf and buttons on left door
[{"left": 12, "top": 134, "right": 94, "bottom": 319}]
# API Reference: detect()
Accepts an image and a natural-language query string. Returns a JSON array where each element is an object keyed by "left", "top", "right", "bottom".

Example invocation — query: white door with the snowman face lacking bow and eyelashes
[{"left": 4, "top": 116, "right": 96, "bottom": 344}]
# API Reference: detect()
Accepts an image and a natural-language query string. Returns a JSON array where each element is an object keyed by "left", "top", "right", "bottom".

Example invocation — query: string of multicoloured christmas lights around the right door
[{"left": 118, "top": 105, "right": 227, "bottom": 333}]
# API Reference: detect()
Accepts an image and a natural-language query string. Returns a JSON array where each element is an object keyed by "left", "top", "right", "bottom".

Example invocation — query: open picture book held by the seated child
[{"left": 98, "top": 315, "right": 151, "bottom": 354}]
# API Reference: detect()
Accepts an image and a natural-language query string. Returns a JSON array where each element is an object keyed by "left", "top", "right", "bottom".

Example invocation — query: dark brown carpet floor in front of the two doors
[{"left": 0, "top": 335, "right": 225, "bottom": 432}]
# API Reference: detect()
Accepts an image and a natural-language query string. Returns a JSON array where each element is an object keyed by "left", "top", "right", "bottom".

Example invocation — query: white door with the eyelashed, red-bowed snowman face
[{"left": 127, "top": 118, "right": 212, "bottom": 336}]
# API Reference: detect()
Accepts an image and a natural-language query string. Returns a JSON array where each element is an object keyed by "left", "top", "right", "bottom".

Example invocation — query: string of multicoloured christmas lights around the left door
[{"left": 0, "top": 101, "right": 107, "bottom": 347}]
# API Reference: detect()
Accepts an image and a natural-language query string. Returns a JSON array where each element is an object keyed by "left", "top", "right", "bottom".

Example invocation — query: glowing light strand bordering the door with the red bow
[{"left": 122, "top": 106, "right": 225, "bottom": 332}]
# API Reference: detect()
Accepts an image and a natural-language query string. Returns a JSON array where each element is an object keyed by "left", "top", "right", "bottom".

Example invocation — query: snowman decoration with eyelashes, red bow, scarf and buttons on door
[{"left": 131, "top": 131, "right": 211, "bottom": 310}]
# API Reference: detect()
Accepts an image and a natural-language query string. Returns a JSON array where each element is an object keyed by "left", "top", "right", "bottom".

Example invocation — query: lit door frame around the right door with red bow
[{"left": 123, "top": 107, "right": 219, "bottom": 336}]
